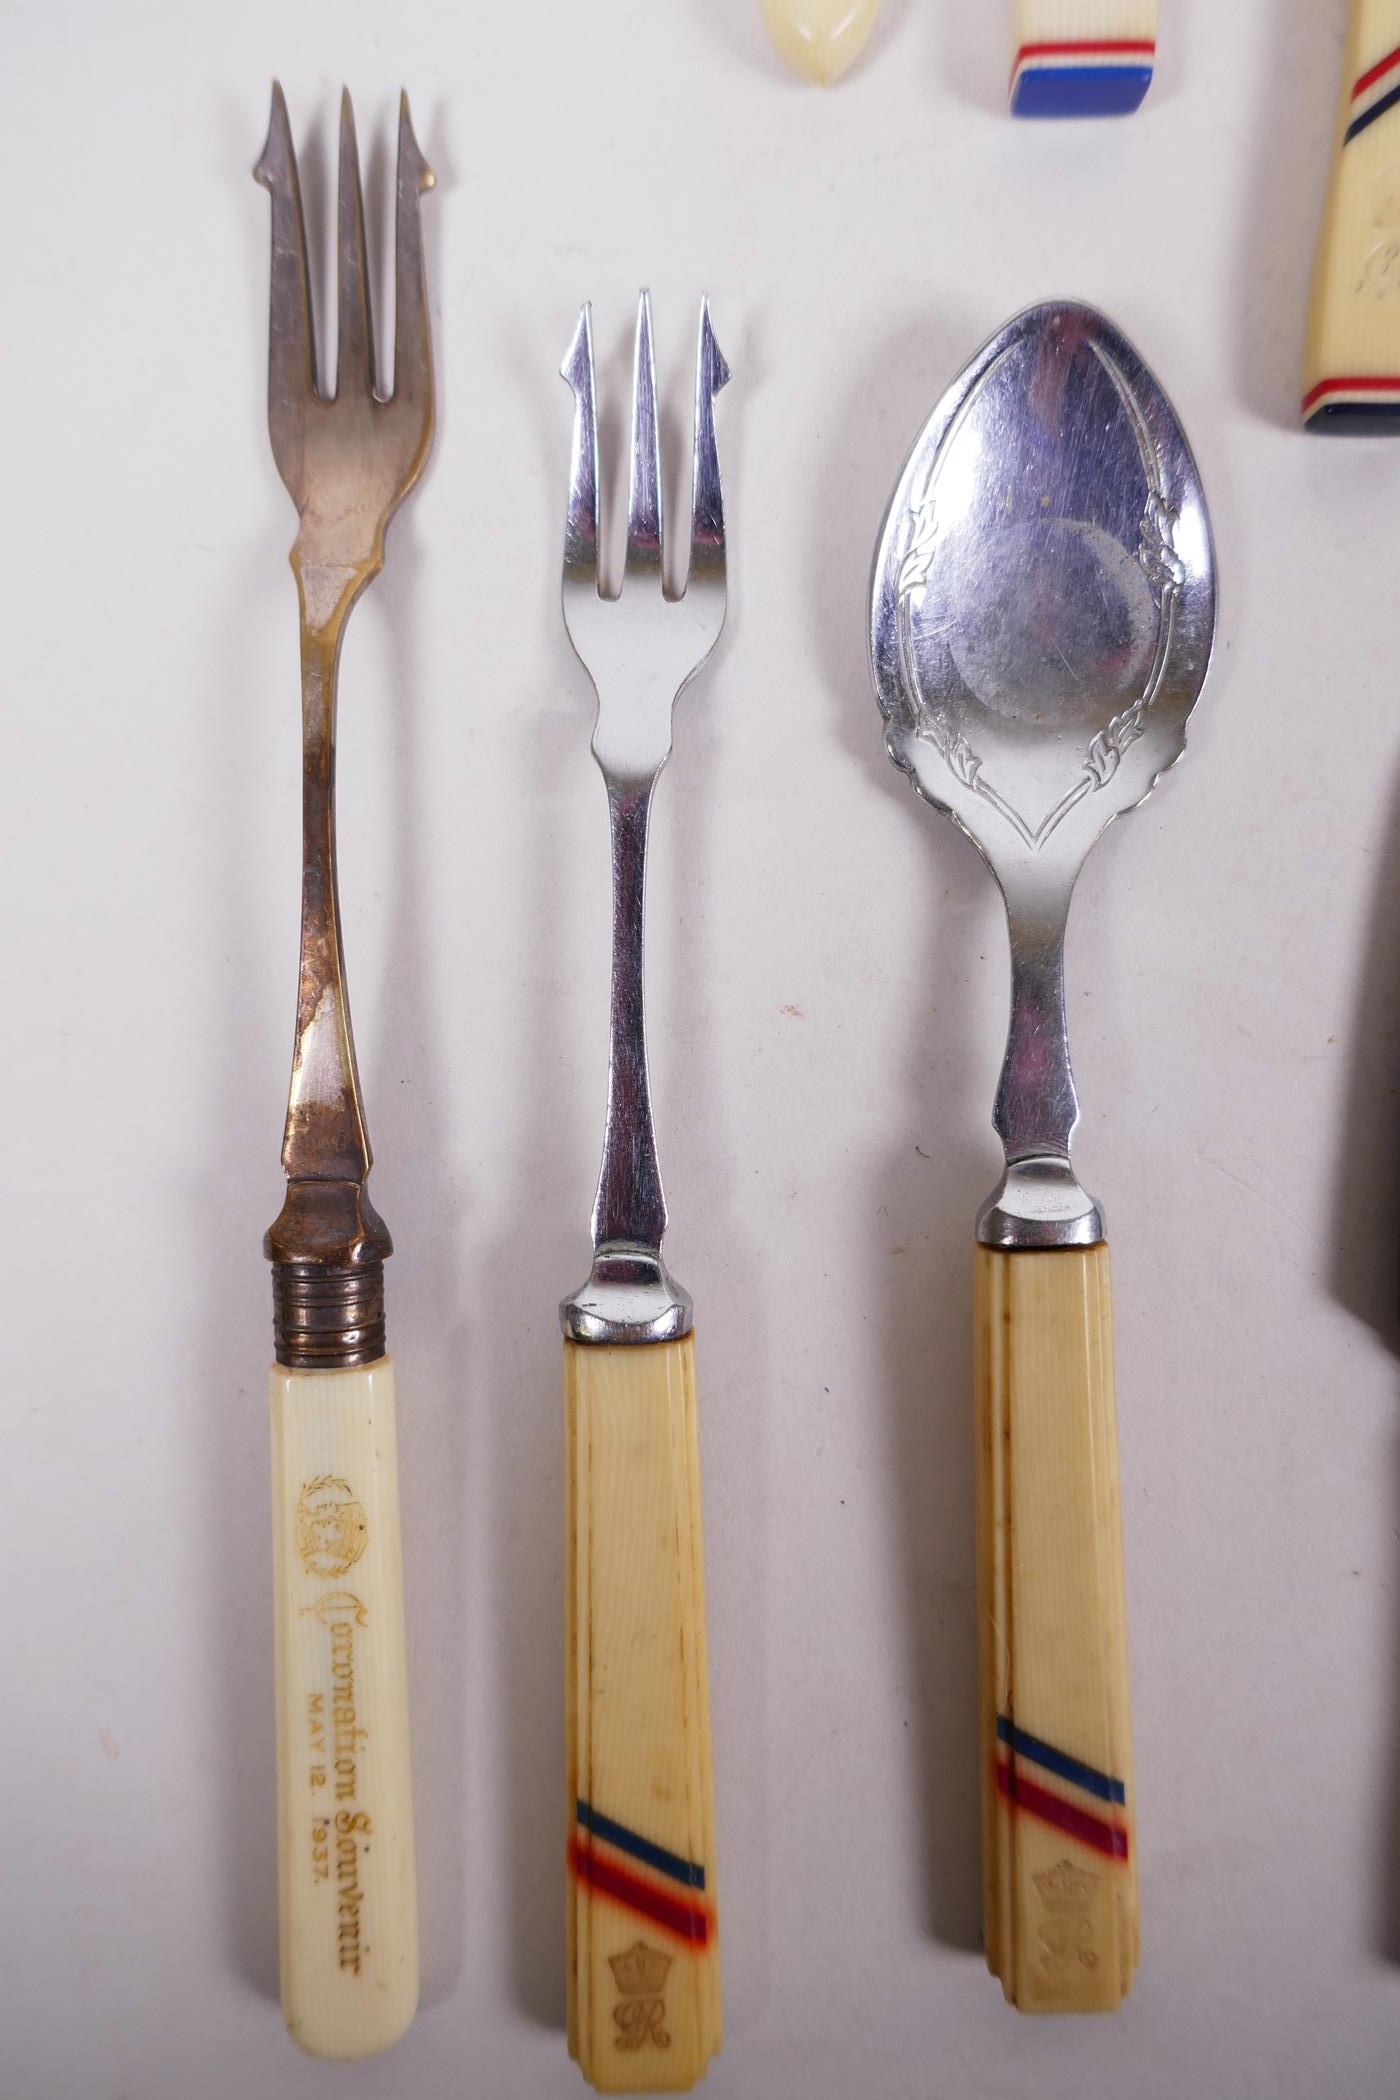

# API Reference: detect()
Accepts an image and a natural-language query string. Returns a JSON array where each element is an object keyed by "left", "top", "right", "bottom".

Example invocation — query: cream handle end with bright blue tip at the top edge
[{"left": 1012, "top": 0, "right": 1157, "bottom": 118}]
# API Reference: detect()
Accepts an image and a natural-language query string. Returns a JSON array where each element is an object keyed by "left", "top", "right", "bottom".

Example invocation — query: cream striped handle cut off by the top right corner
[{"left": 1303, "top": 0, "right": 1400, "bottom": 435}]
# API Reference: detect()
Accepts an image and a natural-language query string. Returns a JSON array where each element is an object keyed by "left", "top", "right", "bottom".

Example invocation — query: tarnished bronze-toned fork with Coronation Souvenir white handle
[{"left": 254, "top": 86, "right": 432, "bottom": 2056}]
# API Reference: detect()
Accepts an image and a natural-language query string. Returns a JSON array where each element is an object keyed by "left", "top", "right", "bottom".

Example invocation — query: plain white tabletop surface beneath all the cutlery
[{"left": 0, "top": 0, "right": 1400, "bottom": 2100}]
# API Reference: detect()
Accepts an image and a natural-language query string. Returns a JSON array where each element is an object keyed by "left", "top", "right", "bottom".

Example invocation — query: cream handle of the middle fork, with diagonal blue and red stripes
[{"left": 565, "top": 1336, "right": 722, "bottom": 2094}]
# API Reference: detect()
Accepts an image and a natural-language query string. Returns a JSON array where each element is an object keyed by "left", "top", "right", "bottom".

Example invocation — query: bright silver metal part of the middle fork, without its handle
[{"left": 558, "top": 292, "right": 728, "bottom": 1342}]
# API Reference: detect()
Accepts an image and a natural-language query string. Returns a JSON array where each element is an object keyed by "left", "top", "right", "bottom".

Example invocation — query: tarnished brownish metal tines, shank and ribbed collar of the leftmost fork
[{"left": 254, "top": 84, "right": 432, "bottom": 1369}]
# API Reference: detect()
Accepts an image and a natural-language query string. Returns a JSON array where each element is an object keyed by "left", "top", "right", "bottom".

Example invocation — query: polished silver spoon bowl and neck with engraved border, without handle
[{"left": 869, "top": 302, "right": 1215, "bottom": 1247}]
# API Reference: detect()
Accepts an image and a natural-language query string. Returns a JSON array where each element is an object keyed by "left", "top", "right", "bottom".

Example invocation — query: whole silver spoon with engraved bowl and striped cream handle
[{"left": 871, "top": 302, "right": 1215, "bottom": 2012}]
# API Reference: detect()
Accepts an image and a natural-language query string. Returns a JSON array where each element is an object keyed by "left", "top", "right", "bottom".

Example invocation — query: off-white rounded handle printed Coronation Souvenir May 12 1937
[{"left": 271, "top": 1357, "right": 418, "bottom": 2058}]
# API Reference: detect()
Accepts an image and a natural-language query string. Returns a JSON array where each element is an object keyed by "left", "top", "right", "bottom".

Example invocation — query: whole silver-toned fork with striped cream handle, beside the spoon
[{"left": 560, "top": 292, "right": 728, "bottom": 2092}]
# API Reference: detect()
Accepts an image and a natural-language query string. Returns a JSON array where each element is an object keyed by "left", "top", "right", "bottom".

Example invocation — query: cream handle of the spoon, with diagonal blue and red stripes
[{"left": 976, "top": 1245, "right": 1138, "bottom": 2012}]
